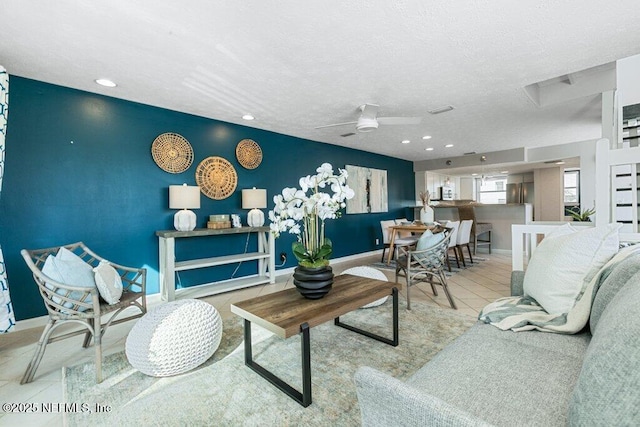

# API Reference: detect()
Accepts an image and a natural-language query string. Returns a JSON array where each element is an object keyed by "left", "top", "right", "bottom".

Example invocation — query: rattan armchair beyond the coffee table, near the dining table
[{"left": 396, "top": 229, "right": 457, "bottom": 310}]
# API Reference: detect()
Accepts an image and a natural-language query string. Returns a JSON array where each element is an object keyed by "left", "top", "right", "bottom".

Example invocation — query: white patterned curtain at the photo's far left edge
[{"left": 0, "top": 65, "right": 15, "bottom": 333}]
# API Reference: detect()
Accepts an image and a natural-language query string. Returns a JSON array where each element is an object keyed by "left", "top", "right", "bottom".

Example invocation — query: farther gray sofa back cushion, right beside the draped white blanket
[{"left": 589, "top": 253, "right": 640, "bottom": 333}]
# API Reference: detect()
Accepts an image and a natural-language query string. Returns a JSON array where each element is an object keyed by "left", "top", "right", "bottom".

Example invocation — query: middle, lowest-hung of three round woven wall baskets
[{"left": 196, "top": 156, "right": 238, "bottom": 200}]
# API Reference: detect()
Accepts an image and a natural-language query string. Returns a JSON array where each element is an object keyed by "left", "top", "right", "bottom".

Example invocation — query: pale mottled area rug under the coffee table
[{"left": 63, "top": 299, "right": 475, "bottom": 426}]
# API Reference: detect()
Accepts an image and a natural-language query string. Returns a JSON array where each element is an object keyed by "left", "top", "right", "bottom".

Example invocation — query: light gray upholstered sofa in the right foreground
[{"left": 355, "top": 256, "right": 640, "bottom": 426}]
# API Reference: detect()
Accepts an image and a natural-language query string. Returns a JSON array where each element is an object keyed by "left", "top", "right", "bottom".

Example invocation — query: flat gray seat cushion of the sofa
[{"left": 408, "top": 323, "right": 589, "bottom": 426}]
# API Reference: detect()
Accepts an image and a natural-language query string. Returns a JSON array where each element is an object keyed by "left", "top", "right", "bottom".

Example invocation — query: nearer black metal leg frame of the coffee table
[{"left": 244, "top": 319, "right": 311, "bottom": 408}]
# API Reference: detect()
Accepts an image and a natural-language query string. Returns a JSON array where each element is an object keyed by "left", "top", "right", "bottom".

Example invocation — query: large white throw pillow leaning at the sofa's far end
[{"left": 523, "top": 224, "right": 621, "bottom": 314}]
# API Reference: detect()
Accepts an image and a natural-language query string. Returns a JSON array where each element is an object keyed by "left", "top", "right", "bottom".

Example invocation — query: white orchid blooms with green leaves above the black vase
[{"left": 269, "top": 163, "right": 355, "bottom": 267}]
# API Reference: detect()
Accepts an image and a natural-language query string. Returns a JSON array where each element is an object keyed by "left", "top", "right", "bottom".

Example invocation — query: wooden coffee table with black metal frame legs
[{"left": 231, "top": 274, "right": 399, "bottom": 407}]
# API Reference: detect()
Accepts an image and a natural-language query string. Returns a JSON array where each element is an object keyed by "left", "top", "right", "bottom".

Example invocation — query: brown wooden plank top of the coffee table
[{"left": 231, "top": 274, "right": 401, "bottom": 338}]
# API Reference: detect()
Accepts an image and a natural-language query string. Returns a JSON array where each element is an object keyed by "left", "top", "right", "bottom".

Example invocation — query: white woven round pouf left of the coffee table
[{"left": 125, "top": 299, "right": 222, "bottom": 377}]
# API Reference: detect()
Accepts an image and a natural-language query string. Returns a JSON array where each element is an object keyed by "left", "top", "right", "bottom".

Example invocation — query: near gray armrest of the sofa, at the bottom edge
[{"left": 355, "top": 366, "right": 489, "bottom": 427}]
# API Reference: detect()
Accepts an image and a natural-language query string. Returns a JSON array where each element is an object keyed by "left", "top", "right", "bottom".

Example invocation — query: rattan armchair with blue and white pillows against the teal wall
[{"left": 20, "top": 242, "right": 147, "bottom": 384}]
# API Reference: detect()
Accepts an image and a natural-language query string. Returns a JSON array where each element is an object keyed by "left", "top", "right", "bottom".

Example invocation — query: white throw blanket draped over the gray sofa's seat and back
[{"left": 478, "top": 245, "right": 640, "bottom": 334}]
